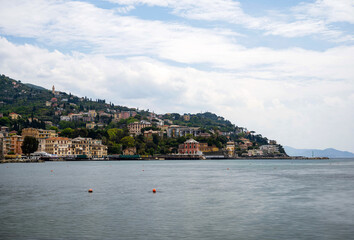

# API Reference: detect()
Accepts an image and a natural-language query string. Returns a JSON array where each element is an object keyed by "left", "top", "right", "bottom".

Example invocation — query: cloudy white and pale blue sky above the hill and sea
[{"left": 0, "top": 0, "right": 354, "bottom": 152}]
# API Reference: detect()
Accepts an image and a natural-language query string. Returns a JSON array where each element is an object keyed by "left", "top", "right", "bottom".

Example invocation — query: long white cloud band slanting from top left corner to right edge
[{"left": 0, "top": 0, "right": 353, "bottom": 76}]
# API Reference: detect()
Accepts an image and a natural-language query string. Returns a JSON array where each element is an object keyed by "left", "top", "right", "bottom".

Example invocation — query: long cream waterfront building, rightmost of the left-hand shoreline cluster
[{"left": 71, "top": 137, "right": 107, "bottom": 158}]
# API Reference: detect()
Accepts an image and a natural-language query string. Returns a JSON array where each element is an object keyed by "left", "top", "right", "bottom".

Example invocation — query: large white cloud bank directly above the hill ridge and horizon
[{"left": 0, "top": 38, "right": 354, "bottom": 151}]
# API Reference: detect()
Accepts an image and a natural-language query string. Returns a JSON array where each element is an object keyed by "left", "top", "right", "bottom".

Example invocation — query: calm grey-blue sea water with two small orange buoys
[{"left": 0, "top": 159, "right": 354, "bottom": 239}]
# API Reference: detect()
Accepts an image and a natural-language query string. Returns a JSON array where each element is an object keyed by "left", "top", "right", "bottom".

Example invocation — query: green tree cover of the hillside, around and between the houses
[{"left": 0, "top": 75, "right": 283, "bottom": 155}]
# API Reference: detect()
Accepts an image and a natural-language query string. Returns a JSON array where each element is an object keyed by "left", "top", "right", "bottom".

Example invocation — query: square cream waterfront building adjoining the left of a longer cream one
[{"left": 45, "top": 137, "right": 72, "bottom": 156}]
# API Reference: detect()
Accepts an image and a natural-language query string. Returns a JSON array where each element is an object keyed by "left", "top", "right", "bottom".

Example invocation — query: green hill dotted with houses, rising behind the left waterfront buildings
[{"left": 0, "top": 75, "right": 286, "bottom": 157}]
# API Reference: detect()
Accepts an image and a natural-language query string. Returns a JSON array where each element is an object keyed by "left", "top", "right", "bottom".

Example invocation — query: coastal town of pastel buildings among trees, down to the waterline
[{"left": 0, "top": 81, "right": 288, "bottom": 160}]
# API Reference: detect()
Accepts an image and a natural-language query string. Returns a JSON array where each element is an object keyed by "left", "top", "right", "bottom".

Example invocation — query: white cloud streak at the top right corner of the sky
[{"left": 109, "top": 0, "right": 354, "bottom": 42}]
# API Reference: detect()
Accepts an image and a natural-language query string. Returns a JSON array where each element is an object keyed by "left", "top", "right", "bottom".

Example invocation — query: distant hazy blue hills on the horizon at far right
[{"left": 284, "top": 146, "right": 354, "bottom": 158}]
